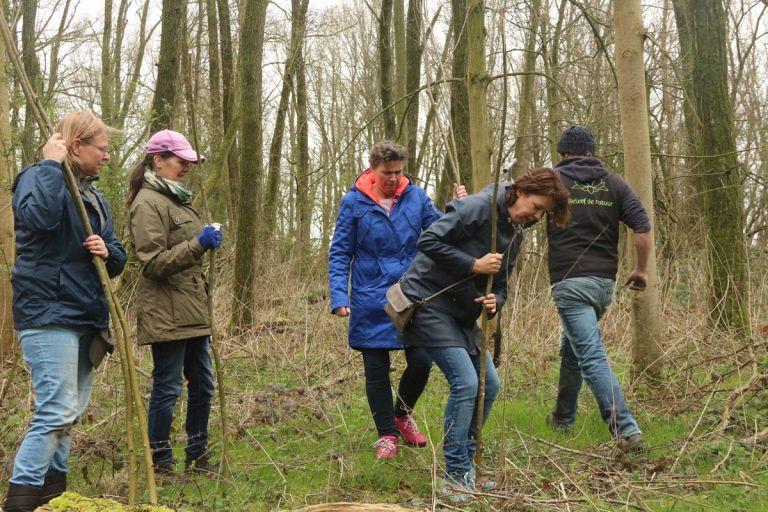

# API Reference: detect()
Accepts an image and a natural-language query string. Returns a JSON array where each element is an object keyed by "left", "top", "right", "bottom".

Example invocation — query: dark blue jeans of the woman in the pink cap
[{"left": 147, "top": 336, "right": 213, "bottom": 463}]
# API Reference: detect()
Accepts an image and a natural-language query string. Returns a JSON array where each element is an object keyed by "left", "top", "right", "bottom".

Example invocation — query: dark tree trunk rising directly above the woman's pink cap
[{"left": 150, "top": 0, "right": 187, "bottom": 133}]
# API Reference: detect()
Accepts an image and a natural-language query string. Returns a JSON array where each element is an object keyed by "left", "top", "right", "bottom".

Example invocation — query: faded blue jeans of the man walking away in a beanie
[{"left": 552, "top": 276, "right": 640, "bottom": 437}]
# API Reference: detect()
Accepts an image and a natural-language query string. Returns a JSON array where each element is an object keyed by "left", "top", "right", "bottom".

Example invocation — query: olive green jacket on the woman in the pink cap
[{"left": 128, "top": 182, "right": 211, "bottom": 345}]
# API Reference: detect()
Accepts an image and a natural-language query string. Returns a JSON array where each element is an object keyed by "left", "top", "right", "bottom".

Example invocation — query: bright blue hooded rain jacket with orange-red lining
[{"left": 329, "top": 169, "right": 443, "bottom": 350}]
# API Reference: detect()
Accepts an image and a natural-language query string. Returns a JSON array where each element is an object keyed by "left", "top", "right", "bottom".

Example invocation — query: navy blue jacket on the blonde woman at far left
[{"left": 11, "top": 160, "right": 126, "bottom": 330}]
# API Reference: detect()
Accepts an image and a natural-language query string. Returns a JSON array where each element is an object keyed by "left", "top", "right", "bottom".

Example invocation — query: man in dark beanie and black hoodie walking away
[{"left": 547, "top": 125, "right": 651, "bottom": 451}]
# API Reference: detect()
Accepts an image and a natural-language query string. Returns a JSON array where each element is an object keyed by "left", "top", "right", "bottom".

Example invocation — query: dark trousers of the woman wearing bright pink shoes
[{"left": 360, "top": 347, "right": 432, "bottom": 436}]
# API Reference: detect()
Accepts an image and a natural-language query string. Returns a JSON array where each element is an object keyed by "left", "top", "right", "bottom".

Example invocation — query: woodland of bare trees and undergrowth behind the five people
[{"left": 0, "top": 0, "right": 768, "bottom": 511}]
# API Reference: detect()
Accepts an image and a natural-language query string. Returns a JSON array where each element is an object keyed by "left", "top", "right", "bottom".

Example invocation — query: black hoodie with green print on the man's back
[{"left": 547, "top": 156, "right": 651, "bottom": 284}]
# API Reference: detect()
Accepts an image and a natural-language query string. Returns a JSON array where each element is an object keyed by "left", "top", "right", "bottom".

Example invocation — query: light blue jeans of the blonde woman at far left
[{"left": 10, "top": 325, "right": 96, "bottom": 487}]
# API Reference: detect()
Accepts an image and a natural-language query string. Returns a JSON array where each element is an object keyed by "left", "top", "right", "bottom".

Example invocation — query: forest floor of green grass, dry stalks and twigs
[{"left": 0, "top": 254, "right": 768, "bottom": 511}]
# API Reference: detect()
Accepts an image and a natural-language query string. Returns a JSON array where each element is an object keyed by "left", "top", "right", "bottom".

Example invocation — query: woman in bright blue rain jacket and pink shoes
[{"left": 329, "top": 141, "right": 466, "bottom": 459}]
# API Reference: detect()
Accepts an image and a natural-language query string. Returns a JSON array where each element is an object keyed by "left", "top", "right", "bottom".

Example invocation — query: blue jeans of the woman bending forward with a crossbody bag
[{"left": 424, "top": 347, "right": 499, "bottom": 480}]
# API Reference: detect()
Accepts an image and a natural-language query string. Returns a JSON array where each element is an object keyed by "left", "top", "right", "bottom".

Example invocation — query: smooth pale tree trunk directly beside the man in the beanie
[{"left": 613, "top": 0, "right": 662, "bottom": 378}]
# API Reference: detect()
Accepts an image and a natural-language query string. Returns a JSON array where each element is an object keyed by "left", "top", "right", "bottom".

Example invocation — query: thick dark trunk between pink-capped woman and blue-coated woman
[{"left": 232, "top": 0, "right": 273, "bottom": 328}]
